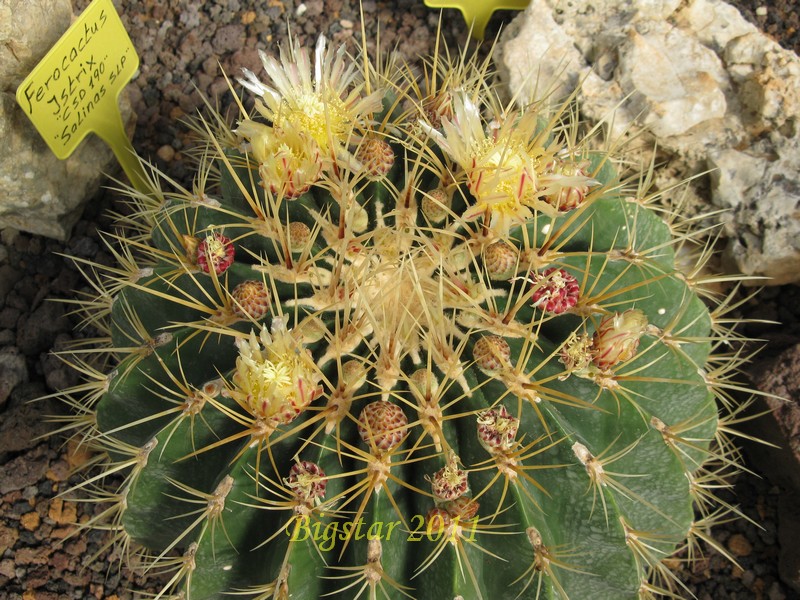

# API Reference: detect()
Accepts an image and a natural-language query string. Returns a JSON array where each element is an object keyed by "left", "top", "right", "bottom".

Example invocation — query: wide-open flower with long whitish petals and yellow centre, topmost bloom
[{"left": 240, "top": 36, "right": 382, "bottom": 158}]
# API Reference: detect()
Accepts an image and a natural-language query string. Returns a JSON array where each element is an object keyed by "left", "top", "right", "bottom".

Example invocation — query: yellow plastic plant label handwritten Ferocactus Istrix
[{"left": 17, "top": 0, "right": 146, "bottom": 190}]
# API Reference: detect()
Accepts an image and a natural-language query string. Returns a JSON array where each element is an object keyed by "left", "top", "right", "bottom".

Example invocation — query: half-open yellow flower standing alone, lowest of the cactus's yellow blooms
[{"left": 231, "top": 318, "right": 322, "bottom": 425}]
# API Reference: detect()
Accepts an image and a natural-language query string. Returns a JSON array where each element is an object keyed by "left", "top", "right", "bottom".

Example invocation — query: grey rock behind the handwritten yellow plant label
[{"left": 0, "top": 0, "right": 132, "bottom": 240}]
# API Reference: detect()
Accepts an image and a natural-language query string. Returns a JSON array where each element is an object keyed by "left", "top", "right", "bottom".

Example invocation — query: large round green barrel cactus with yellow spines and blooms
[{"left": 64, "top": 32, "right": 752, "bottom": 600}]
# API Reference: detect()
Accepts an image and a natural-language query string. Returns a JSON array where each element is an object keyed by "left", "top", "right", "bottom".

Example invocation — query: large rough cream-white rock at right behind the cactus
[{"left": 498, "top": 0, "right": 800, "bottom": 284}]
